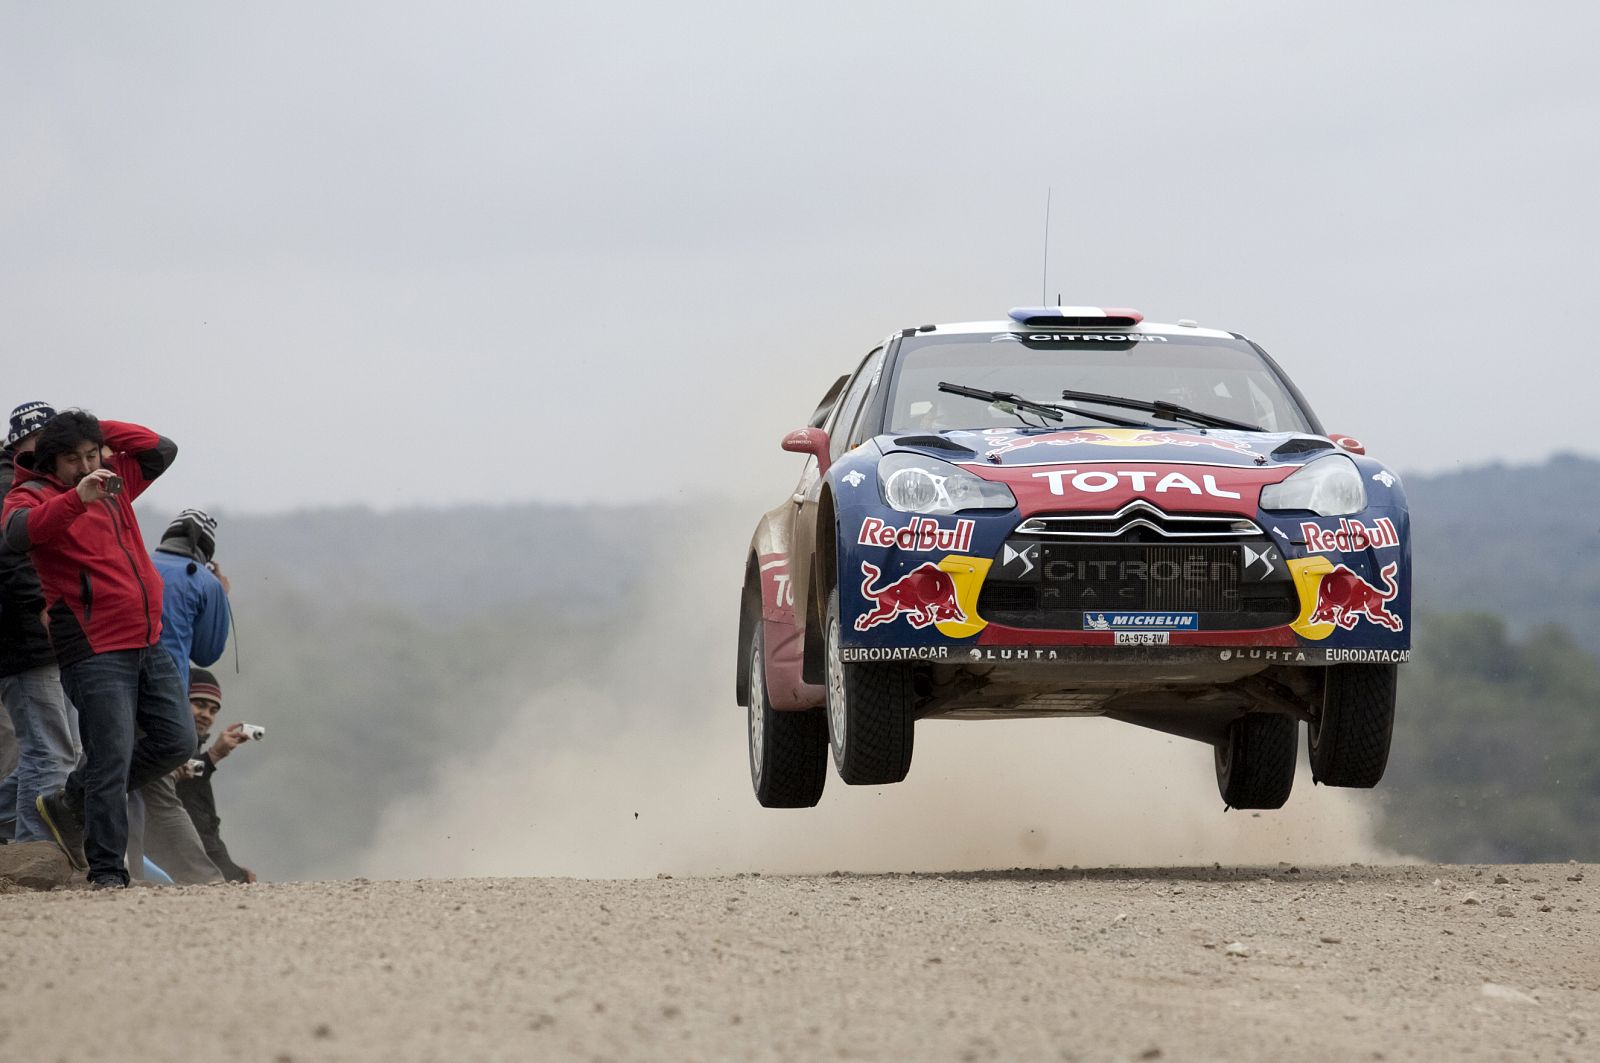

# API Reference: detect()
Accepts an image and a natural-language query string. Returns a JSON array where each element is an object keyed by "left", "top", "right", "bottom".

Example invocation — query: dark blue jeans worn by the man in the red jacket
[{"left": 61, "top": 645, "right": 198, "bottom": 882}]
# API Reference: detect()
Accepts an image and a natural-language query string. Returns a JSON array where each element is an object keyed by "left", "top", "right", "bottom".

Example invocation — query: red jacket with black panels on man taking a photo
[{"left": 0, "top": 421, "right": 178, "bottom": 664}]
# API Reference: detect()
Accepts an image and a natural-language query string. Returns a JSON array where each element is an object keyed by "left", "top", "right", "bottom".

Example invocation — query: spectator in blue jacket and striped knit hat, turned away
[{"left": 128, "top": 509, "right": 227, "bottom": 885}]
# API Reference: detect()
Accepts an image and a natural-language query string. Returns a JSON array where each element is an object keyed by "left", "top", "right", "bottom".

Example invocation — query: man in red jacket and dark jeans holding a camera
[{"left": 0, "top": 410, "right": 195, "bottom": 887}]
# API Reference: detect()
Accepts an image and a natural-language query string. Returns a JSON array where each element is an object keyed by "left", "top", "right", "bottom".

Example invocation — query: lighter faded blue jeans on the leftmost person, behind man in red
[{"left": 0, "top": 664, "right": 78, "bottom": 842}]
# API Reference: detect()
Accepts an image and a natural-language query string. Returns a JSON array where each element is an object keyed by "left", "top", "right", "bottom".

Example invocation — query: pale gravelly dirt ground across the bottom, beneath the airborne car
[{"left": 0, "top": 864, "right": 1600, "bottom": 1063}]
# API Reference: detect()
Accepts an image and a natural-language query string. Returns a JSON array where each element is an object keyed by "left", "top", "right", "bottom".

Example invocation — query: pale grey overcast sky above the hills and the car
[{"left": 0, "top": 0, "right": 1600, "bottom": 520}]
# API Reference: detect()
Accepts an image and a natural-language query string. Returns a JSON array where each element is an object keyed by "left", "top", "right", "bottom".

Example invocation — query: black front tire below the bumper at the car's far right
[{"left": 1306, "top": 664, "right": 1398, "bottom": 788}]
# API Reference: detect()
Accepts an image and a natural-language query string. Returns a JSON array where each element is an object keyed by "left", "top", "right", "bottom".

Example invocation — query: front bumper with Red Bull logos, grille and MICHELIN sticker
[{"left": 837, "top": 509, "right": 1411, "bottom": 666}]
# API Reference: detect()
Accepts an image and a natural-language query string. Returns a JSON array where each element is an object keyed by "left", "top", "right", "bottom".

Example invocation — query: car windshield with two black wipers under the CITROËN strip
[{"left": 885, "top": 333, "right": 1312, "bottom": 432}]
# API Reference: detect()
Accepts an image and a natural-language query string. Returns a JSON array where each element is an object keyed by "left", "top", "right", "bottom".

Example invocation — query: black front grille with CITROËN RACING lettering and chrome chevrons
[{"left": 978, "top": 504, "right": 1299, "bottom": 631}]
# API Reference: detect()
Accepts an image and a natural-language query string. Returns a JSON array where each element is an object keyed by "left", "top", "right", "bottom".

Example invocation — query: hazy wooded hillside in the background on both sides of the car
[{"left": 128, "top": 456, "right": 1600, "bottom": 877}]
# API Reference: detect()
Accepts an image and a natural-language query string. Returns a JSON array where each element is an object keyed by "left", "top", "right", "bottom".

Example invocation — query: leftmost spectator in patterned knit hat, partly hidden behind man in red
[{"left": 0, "top": 402, "right": 78, "bottom": 842}]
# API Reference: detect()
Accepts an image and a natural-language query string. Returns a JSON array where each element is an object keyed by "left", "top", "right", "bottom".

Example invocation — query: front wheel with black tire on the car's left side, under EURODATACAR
[{"left": 824, "top": 588, "right": 917, "bottom": 786}]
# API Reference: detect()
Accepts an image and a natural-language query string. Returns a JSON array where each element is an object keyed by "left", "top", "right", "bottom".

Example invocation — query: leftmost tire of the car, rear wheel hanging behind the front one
[{"left": 746, "top": 616, "right": 827, "bottom": 808}]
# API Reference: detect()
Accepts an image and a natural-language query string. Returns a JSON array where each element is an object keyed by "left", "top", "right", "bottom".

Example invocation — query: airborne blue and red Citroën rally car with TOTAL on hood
[{"left": 736, "top": 307, "right": 1411, "bottom": 808}]
